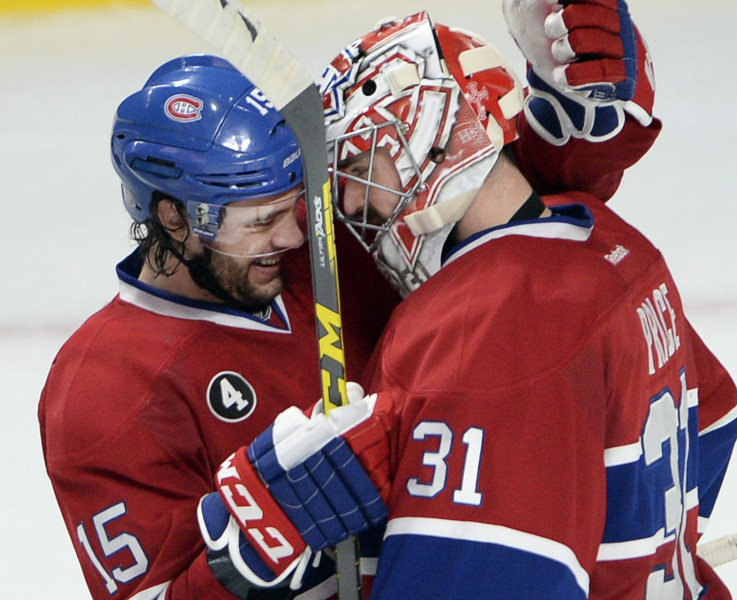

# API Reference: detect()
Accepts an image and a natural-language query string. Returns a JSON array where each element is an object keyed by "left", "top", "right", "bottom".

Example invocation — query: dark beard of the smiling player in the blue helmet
[{"left": 187, "top": 250, "right": 284, "bottom": 313}]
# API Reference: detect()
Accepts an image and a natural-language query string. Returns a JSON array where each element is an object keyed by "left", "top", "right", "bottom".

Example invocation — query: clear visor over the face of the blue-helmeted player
[{"left": 188, "top": 189, "right": 307, "bottom": 259}]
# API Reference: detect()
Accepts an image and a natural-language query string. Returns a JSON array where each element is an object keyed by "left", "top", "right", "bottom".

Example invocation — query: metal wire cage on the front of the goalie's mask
[{"left": 328, "top": 119, "right": 423, "bottom": 252}]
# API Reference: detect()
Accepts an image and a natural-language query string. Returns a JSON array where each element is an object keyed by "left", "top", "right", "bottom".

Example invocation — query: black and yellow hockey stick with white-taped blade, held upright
[{"left": 147, "top": 0, "right": 361, "bottom": 600}]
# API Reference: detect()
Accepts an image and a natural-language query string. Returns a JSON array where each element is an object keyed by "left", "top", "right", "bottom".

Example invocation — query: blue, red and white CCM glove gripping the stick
[{"left": 199, "top": 384, "right": 393, "bottom": 586}]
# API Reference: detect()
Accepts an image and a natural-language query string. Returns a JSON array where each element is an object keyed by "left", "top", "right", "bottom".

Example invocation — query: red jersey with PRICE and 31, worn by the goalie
[{"left": 367, "top": 193, "right": 737, "bottom": 600}]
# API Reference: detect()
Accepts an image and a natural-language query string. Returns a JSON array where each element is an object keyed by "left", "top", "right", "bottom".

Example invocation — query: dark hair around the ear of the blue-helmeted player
[{"left": 130, "top": 193, "right": 191, "bottom": 276}]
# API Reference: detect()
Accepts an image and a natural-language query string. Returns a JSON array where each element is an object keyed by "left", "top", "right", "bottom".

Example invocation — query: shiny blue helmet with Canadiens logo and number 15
[{"left": 111, "top": 55, "right": 304, "bottom": 230}]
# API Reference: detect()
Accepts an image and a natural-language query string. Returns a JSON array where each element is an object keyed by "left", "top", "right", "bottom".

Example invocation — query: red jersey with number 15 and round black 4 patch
[{"left": 39, "top": 115, "right": 660, "bottom": 600}]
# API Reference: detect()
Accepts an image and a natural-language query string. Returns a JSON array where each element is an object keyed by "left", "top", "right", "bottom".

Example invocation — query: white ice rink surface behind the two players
[{"left": 0, "top": 0, "right": 737, "bottom": 600}]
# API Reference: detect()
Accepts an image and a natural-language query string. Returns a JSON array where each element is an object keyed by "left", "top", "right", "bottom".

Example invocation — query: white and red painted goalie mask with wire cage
[{"left": 321, "top": 12, "right": 523, "bottom": 296}]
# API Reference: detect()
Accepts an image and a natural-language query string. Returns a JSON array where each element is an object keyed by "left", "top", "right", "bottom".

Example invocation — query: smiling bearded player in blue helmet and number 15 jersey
[{"left": 39, "top": 2, "right": 676, "bottom": 600}]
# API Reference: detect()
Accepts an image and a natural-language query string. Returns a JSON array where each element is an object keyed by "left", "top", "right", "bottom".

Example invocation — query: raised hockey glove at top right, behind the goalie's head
[{"left": 503, "top": 0, "right": 655, "bottom": 146}]
